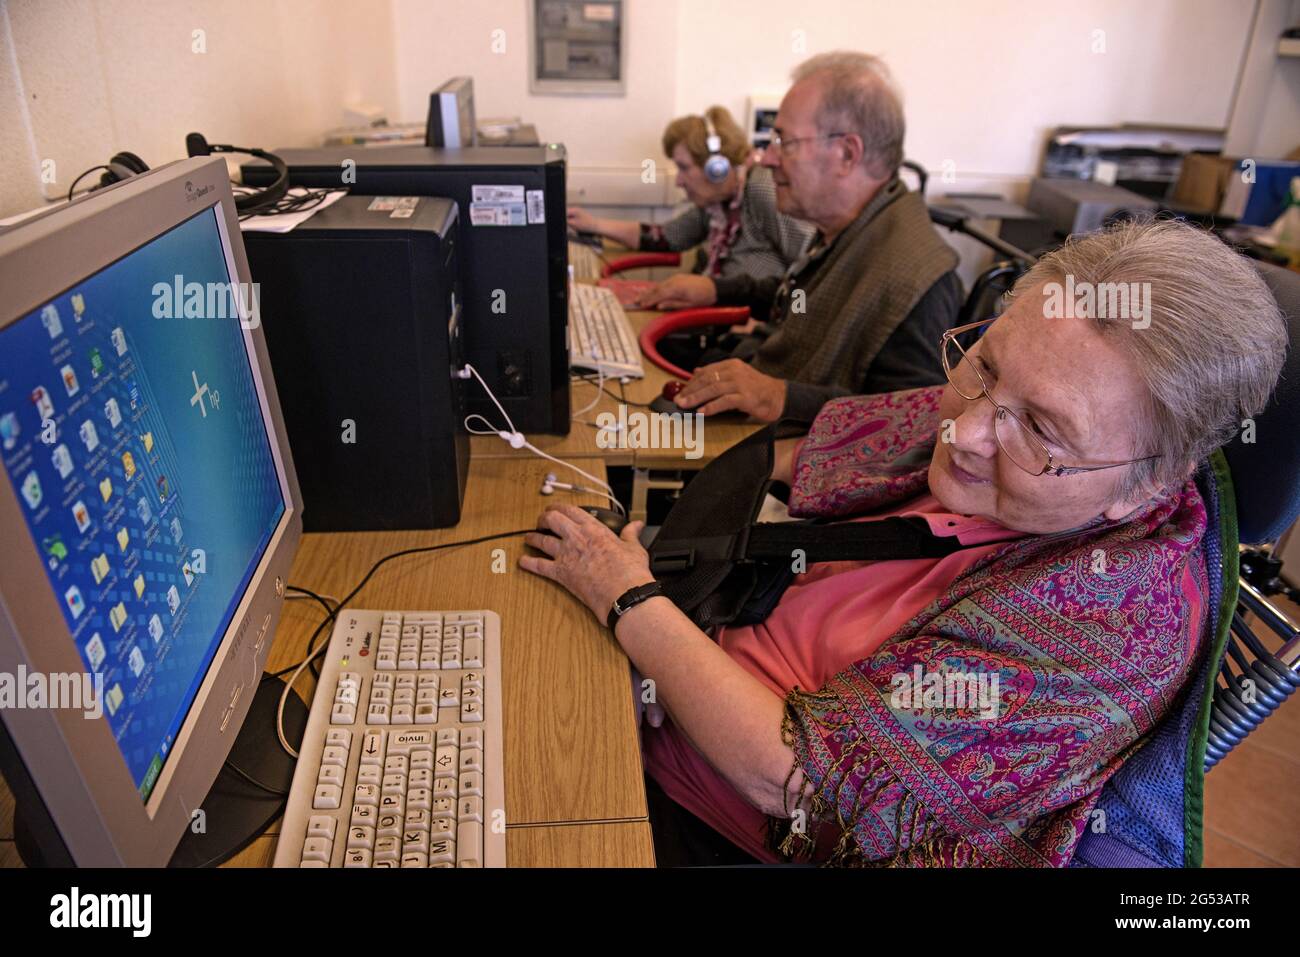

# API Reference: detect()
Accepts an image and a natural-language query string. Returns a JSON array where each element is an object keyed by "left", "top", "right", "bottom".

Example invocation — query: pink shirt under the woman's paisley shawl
[{"left": 641, "top": 493, "right": 1023, "bottom": 862}]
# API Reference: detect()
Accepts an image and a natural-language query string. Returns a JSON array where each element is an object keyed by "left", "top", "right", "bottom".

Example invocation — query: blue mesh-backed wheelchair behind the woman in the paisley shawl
[{"left": 1071, "top": 263, "right": 1300, "bottom": 867}]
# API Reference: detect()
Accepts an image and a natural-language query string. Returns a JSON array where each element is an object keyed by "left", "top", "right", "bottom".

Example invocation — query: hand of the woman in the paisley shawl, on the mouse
[{"left": 519, "top": 505, "right": 654, "bottom": 624}]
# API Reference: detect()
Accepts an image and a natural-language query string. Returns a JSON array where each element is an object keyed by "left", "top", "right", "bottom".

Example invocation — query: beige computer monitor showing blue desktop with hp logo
[{"left": 0, "top": 157, "right": 302, "bottom": 866}]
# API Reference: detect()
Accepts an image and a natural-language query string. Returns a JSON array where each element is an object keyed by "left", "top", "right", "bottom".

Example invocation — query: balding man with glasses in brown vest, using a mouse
[{"left": 644, "top": 52, "right": 962, "bottom": 421}]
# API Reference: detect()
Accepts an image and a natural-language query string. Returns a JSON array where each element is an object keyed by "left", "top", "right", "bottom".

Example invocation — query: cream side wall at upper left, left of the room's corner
[{"left": 0, "top": 0, "right": 397, "bottom": 216}]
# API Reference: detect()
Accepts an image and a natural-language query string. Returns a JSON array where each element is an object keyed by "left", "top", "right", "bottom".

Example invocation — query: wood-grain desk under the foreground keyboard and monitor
[{"left": 0, "top": 456, "right": 654, "bottom": 867}]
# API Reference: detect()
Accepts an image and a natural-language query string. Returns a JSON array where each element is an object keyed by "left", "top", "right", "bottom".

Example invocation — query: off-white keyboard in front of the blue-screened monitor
[{"left": 274, "top": 609, "right": 506, "bottom": 867}]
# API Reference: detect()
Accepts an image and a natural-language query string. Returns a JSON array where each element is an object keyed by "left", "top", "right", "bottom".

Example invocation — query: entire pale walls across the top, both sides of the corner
[{"left": 0, "top": 0, "right": 1300, "bottom": 215}]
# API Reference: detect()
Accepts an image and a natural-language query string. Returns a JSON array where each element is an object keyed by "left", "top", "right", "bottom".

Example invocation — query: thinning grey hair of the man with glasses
[{"left": 790, "top": 49, "right": 905, "bottom": 179}]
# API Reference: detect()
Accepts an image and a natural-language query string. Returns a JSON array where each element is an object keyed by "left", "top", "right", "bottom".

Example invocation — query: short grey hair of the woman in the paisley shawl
[{"left": 1011, "top": 218, "right": 1288, "bottom": 498}]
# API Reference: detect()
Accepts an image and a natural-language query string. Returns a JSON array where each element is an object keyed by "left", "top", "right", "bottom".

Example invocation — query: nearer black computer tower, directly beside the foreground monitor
[{"left": 243, "top": 196, "right": 469, "bottom": 532}]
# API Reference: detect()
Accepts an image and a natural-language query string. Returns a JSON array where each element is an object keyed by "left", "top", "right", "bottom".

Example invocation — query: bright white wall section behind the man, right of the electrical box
[{"left": 677, "top": 0, "right": 1274, "bottom": 197}]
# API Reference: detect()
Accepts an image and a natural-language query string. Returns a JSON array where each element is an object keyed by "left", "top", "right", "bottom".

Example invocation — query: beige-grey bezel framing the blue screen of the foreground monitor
[{"left": 0, "top": 157, "right": 302, "bottom": 866}]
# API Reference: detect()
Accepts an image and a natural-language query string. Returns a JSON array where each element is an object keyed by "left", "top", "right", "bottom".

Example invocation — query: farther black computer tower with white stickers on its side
[{"left": 243, "top": 144, "right": 569, "bottom": 436}]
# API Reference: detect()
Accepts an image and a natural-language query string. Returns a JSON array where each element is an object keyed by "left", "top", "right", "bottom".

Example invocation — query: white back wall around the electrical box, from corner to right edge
[{"left": 379, "top": 0, "right": 1300, "bottom": 208}]
